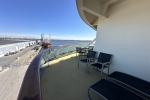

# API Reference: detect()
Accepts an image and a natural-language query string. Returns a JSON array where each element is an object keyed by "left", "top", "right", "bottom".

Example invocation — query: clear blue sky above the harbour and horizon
[{"left": 0, "top": 0, "right": 96, "bottom": 40}]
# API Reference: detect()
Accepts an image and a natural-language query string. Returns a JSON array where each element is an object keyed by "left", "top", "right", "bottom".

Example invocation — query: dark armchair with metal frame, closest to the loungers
[{"left": 91, "top": 52, "right": 112, "bottom": 79}]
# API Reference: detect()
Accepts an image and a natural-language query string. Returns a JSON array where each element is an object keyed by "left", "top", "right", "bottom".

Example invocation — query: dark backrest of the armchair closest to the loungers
[{"left": 98, "top": 52, "right": 112, "bottom": 63}]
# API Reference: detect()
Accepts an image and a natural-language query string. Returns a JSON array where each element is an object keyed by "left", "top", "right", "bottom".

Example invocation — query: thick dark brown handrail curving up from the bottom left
[{"left": 17, "top": 49, "right": 49, "bottom": 100}]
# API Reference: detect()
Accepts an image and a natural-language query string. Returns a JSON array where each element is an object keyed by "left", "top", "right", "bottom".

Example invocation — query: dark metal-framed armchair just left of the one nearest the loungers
[{"left": 78, "top": 51, "right": 96, "bottom": 73}]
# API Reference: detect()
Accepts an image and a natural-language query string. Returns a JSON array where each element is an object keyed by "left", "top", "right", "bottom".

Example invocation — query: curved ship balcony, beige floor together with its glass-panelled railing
[{"left": 18, "top": 41, "right": 149, "bottom": 100}]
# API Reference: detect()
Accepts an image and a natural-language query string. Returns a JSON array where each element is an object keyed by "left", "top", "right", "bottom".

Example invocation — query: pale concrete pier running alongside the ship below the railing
[{"left": 0, "top": 44, "right": 41, "bottom": 100}]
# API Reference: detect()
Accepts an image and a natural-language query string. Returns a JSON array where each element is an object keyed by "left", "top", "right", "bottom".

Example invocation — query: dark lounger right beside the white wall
[{"left": 107, "top": 71, "right": 150, "bottom": 99}]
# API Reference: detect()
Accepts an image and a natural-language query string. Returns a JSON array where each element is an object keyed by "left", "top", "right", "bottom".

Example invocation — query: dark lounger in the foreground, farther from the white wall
[{"left": 88, "top": 79, "right": 146, "bottom": 100}]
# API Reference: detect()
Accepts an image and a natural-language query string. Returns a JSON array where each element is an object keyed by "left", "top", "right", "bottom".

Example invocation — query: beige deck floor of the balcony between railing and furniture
[{"left": 41, "top": 54, "right": 105, "bottom": 100}]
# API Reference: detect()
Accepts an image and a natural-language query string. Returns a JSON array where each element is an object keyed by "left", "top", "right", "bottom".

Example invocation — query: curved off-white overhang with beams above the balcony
[{"left": 76, "top": 0, "right": 125, "bottom": 30}]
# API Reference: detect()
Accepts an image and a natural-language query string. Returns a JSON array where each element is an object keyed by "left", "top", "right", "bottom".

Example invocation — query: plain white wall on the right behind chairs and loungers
[{"left": 95, "top": 0, "right": 150, "bottom": 81}]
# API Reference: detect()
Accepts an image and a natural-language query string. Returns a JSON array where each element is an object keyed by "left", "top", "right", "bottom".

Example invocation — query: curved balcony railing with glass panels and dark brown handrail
[{"left": 17, "top": 40, "right": 95, "bottom": 100}]
